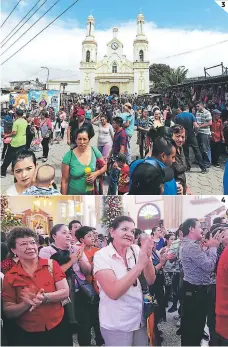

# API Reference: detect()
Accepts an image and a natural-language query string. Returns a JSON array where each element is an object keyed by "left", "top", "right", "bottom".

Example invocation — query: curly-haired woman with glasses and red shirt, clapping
[{"left": 2, "top": 227, "right": 69, "bottom": 346}]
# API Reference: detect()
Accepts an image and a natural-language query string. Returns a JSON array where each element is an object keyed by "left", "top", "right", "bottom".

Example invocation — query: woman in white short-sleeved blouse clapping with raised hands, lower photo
[{"left": 94, "top": 216, "right": 155, "bottom": 346}]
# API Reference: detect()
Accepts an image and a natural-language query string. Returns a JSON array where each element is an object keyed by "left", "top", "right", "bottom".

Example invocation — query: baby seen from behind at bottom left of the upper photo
[{"left": 23, "top": 164, "right": 61, "bottom": 195}]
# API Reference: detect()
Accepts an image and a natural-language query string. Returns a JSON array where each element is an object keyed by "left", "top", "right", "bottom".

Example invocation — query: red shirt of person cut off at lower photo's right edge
[{"left": 215, "top": 246, "right": 228, "bottom": 339}]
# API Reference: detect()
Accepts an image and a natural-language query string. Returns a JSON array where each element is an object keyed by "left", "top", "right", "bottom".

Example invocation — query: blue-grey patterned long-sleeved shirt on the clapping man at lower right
[{"left": 181, "top": 237, "right": 217, "bottom": 285}]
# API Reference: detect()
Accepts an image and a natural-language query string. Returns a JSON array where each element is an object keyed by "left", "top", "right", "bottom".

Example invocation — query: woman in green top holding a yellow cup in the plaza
[{"left": 61, "top": 128, "right": 107, "bottom": 195}]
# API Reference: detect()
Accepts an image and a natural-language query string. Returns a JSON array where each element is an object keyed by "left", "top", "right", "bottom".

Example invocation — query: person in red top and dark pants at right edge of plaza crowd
[{"left": 211, "top": 109, "right": 224, "bottom": 167}]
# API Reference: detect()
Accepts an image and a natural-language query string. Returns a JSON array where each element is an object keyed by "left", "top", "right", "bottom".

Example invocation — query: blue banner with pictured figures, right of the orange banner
[{"left": 28, "top": 90, "right": 60, "bottom": 112}]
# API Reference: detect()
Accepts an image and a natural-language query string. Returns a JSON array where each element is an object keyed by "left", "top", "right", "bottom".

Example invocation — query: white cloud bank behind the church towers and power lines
[{"left": 1, "top": 14, "right": 228, "bottom": 86}]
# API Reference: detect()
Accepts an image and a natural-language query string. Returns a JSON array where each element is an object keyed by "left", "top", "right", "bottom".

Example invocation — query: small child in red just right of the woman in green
[{"left": 117, "top": 153, "right": 130, "bottom": 195}]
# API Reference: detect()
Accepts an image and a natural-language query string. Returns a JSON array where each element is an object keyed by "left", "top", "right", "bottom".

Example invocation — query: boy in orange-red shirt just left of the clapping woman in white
[{"left": 75, "top": 226, "right": 104, "bottom": 346}]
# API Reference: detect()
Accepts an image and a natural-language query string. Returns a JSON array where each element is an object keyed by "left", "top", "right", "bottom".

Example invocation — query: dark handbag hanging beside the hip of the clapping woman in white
[{"left": 131, "top": 247, "right": 158, "bottom": 320}]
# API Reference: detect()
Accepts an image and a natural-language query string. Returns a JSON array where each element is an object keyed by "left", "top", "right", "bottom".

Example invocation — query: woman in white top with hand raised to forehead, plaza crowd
[{"left": 92, "top": 114, "right": 114, "bottom": 159}]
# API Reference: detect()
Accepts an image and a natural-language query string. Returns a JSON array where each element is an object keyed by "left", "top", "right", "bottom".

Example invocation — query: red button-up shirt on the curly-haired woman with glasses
[{"left": 2, "top": 258, "right": 66, "bottom": 332}]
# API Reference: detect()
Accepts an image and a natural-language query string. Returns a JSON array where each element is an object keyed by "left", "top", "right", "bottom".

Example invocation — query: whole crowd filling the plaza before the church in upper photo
[{"left": 1, "top": 95, "right": 228, "bottom": 195}]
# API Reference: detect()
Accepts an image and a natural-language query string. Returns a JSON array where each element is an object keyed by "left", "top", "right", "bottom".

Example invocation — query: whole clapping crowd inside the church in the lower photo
[{"left": 1, "top": 216, "right": 228, "bottom": 346}]
